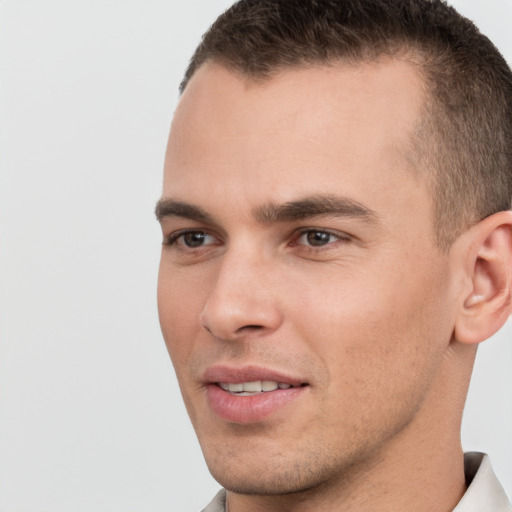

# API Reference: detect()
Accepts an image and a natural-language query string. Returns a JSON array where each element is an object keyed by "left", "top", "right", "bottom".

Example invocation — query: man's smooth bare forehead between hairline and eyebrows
[{"left": 164, "top": 59, "right": 423, "bottom": 228}]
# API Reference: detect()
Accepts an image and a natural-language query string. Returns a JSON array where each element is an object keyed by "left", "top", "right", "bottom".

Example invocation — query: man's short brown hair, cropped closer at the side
[{"left": 180, "top": 0, "right": 512, "bottom": 249}]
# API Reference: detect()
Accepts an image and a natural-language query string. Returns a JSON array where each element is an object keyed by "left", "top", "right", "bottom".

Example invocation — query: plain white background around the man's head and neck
[{"left": 0, "top": 0, "right": 512, "bottom": 512}]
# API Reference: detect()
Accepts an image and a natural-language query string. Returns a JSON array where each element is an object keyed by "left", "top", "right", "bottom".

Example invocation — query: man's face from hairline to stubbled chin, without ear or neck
[{"left": 158, "top": 61, "right": 454, "bottom": 494}]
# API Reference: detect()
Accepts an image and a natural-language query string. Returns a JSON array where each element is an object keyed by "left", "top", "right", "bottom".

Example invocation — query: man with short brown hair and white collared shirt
[{"left": 156, "top": 0, "right": 512, "bottom": 512}]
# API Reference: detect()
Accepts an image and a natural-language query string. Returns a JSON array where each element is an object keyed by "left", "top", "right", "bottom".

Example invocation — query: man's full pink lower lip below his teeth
[{"left": 206, "top": 384, "right": 306, "bottom": 424}]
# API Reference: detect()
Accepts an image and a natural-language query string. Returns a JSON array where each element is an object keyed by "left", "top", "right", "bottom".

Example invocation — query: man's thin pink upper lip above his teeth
[{"left": 203, "top": 365, "right": 305, "bottom": 386}]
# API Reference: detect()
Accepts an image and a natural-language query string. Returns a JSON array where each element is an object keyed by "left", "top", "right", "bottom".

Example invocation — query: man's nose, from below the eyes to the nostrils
[{"left": 200, "top": 251, "right": 282, "bottom": 341}]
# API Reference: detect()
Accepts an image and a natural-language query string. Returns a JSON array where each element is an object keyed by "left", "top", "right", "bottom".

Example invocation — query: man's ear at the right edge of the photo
[{"left": 454, "top": 211, "right": 512, "bottom": 344}]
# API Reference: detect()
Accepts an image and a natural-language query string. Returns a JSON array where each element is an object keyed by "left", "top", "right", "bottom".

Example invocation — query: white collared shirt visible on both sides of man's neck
[{"left": 202, "top": 452, "right": 512, "bottom": 512}]
